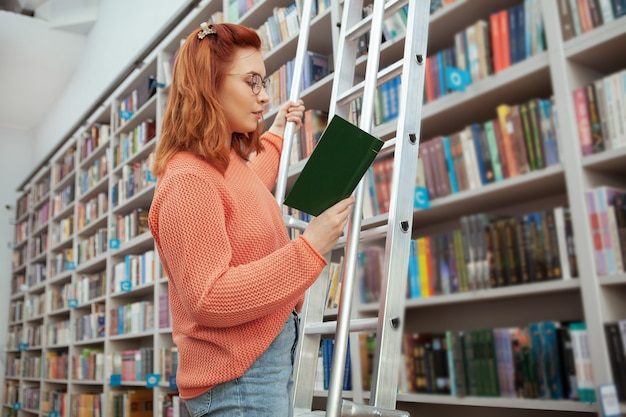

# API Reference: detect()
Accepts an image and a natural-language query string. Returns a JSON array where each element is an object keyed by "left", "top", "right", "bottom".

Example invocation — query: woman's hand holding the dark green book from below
[{"left": 303, "top": 196, "right": 354, "bottom": 256}]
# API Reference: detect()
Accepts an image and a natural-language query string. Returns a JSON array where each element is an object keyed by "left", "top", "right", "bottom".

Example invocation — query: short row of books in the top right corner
[{"left": 558, "top": 0, "right": 626, "bottom": 41}]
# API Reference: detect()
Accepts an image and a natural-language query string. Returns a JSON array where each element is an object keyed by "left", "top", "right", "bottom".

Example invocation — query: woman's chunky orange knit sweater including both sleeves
[{"left": 149, "top": 133, "right": 326, "bottom": 399}]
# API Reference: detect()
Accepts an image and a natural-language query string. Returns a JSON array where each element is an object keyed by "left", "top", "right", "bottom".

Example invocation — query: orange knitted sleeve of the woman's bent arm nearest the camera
[{"left": 150, "top": 173, "right": 326, "bottom": 327}]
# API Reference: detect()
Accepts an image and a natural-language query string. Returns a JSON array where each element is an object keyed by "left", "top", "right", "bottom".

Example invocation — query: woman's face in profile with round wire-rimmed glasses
[{"left": 217, "top": 48, "right": 269, "bottom": 133}]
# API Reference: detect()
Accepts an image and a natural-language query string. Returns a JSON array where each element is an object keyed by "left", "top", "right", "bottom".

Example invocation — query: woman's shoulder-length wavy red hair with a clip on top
[{"left": 152, "top": 23, "right": 263, "bottom": 176}]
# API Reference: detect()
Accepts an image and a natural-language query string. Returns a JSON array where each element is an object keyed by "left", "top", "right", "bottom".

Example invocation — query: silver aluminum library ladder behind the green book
[{"left": 275, "top": 0, "right": 430, "bottom": 417}]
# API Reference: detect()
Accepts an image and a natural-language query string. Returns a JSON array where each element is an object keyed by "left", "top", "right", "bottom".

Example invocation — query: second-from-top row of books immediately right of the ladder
[{"left": 418, "top": 99, "right": 560, "bottom": 200}]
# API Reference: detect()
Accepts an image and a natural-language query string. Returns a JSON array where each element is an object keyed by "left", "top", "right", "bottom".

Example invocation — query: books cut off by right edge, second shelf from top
[{"left": 572, "top": 70, "right": 626, "bottom": 156}]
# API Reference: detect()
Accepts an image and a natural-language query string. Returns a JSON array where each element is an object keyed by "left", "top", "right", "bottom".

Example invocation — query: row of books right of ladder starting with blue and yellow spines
[{"left": 408, "top": 207, "right": 578, "bottom": 298}]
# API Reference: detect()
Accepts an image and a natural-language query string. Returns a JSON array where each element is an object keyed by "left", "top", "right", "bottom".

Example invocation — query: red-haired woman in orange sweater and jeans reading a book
[{"left": 149, "top": 23, "right": 354, "bottom": 417}]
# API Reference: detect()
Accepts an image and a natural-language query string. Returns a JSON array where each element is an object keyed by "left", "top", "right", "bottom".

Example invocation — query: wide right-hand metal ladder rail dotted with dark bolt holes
[{"left": 370, "top": 0, "right": 430, "bottom": 409}]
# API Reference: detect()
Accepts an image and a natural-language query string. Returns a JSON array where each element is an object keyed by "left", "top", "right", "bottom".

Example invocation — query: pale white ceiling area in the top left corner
[{"left": 0, "top": 0, "right": 97, "bottom": 131}]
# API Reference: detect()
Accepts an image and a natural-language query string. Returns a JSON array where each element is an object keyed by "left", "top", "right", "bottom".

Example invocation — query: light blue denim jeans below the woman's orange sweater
[{"left": 185, "top": 313, "right": 299, "bottom": 417}]
